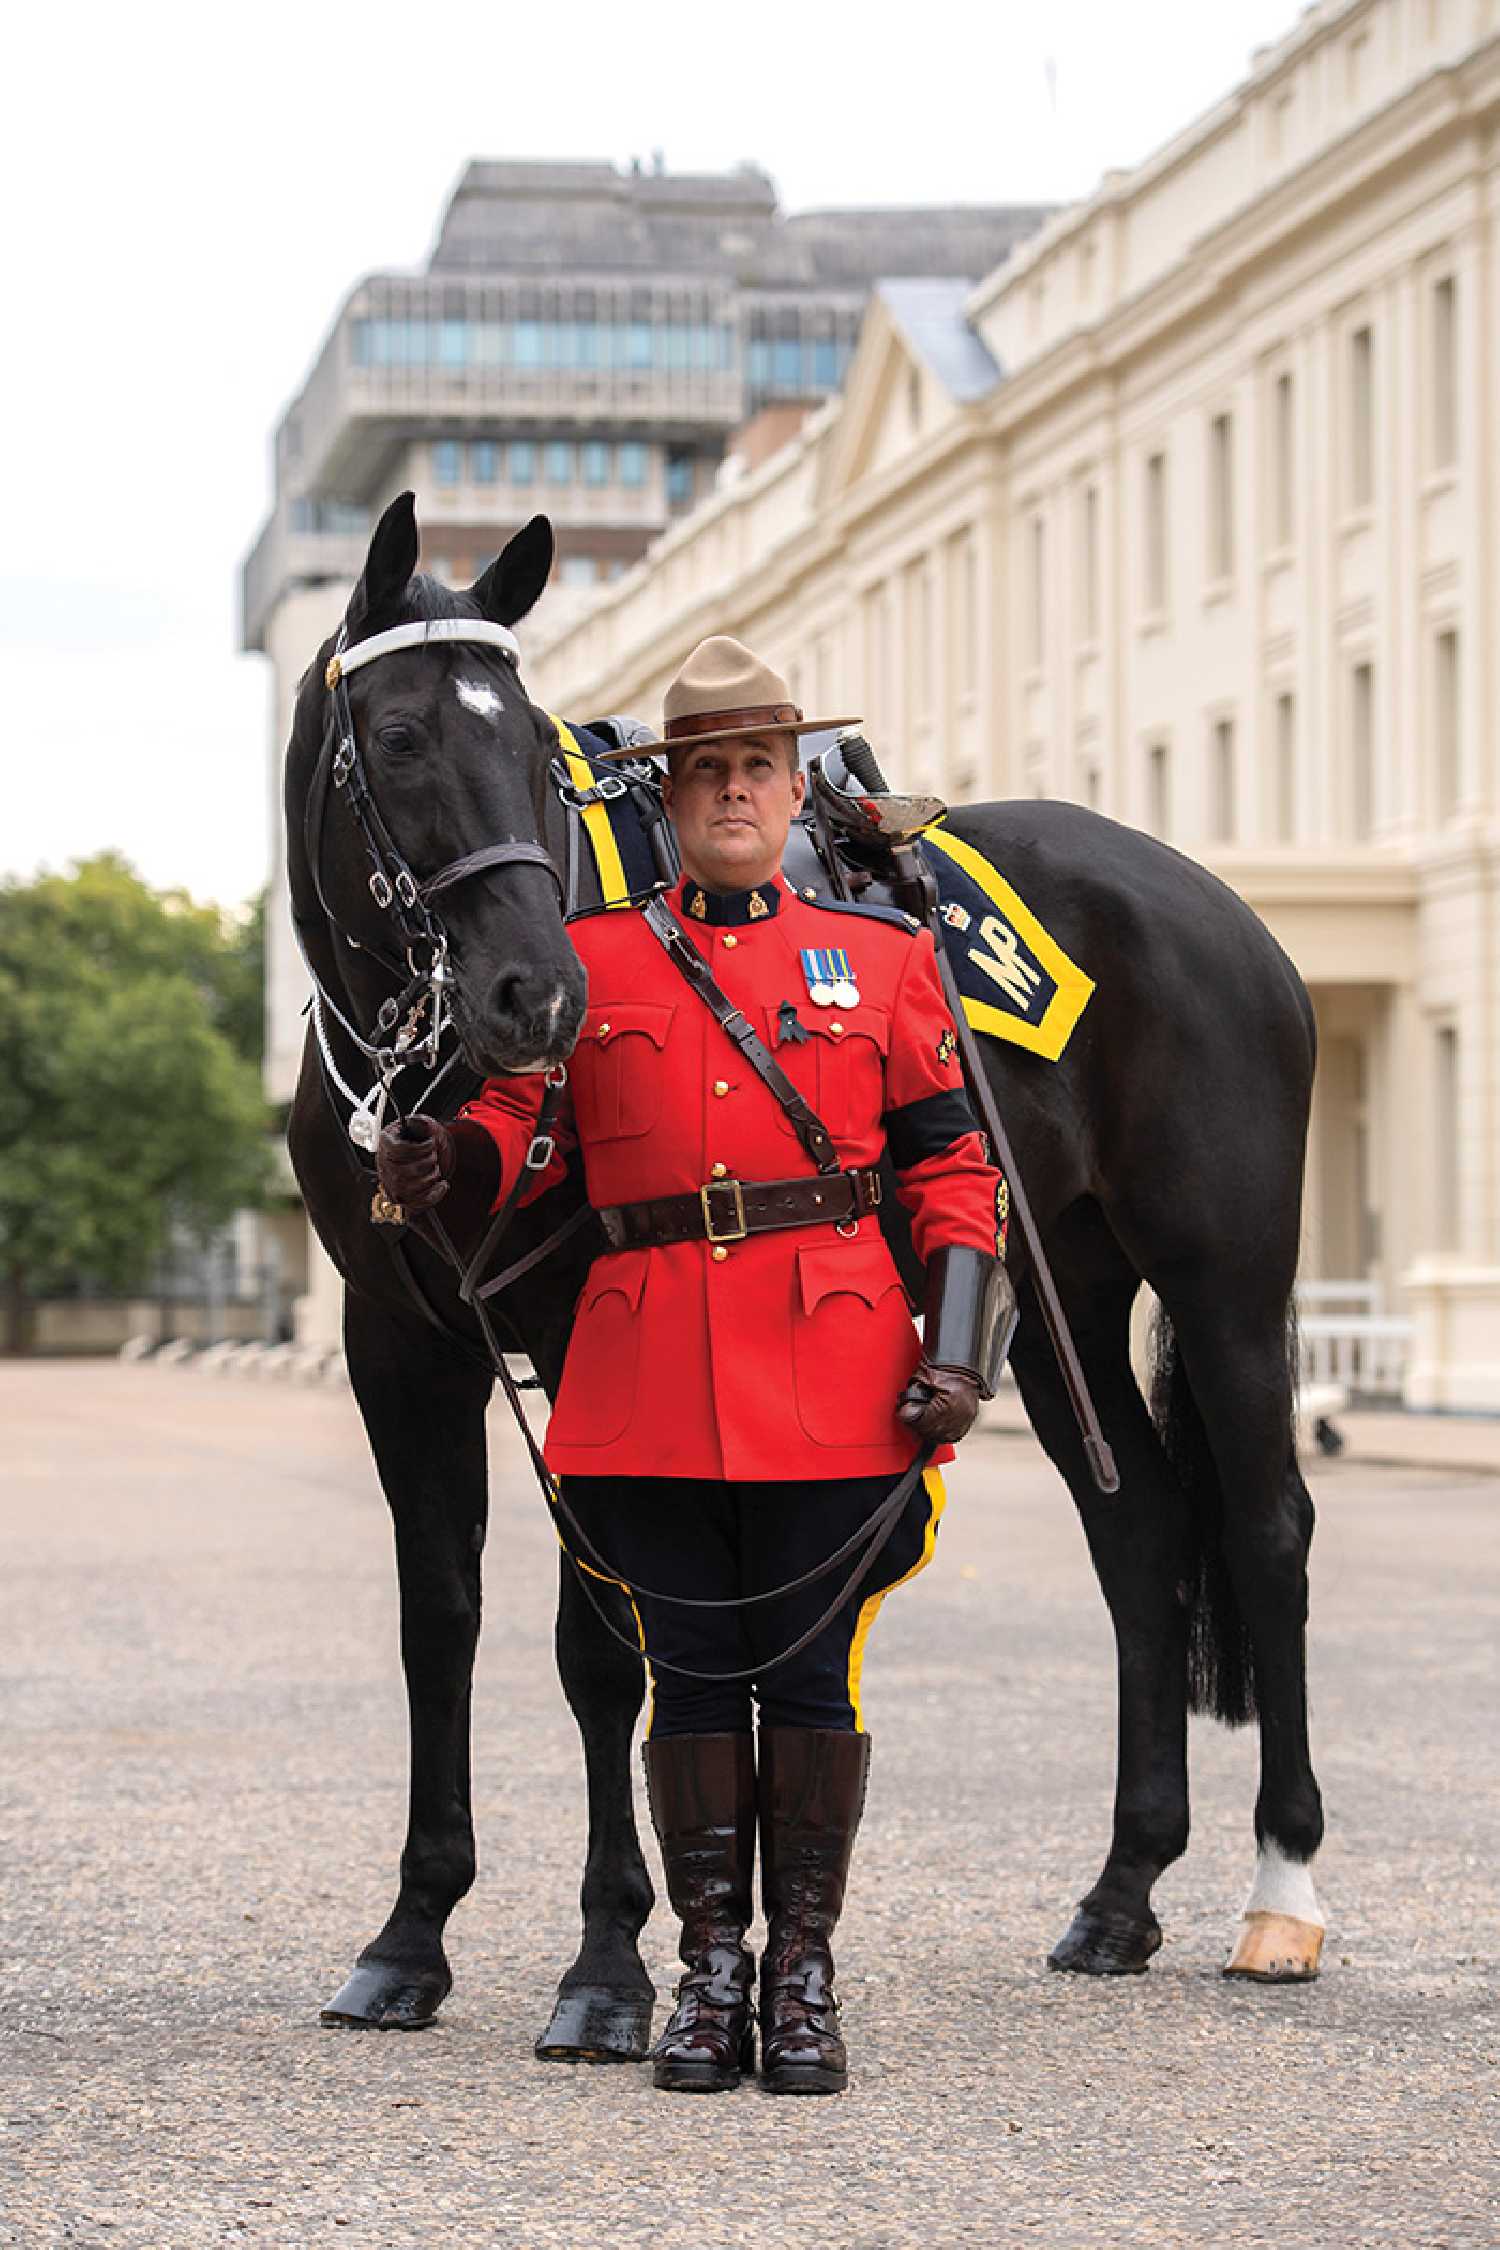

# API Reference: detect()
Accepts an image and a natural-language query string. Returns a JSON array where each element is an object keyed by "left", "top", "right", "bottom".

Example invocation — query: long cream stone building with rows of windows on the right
[{"left": 526, "top": 0, "right": 1500, "bottom": 1411}]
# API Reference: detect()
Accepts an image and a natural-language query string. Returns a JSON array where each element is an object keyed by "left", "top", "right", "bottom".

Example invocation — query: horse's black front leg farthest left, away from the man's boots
[{"left": 322, "top": 1292, "right": 490, "bottom": 2032}]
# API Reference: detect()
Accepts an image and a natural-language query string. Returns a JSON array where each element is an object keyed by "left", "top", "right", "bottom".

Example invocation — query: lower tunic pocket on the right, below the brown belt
[{"left": 792, "top": 1235, "right": 918, "bottom": 1447}]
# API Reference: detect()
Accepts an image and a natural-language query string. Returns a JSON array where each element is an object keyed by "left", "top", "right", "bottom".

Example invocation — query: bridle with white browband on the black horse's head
[{"left": 299, "top": 617, "right": 567, "bottom": 1152}]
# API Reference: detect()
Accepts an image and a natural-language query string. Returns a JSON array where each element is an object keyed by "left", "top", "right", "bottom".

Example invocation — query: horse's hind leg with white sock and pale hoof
[{"left": 1172, "top": 1287, "right": 1322, "bottom": 1985}]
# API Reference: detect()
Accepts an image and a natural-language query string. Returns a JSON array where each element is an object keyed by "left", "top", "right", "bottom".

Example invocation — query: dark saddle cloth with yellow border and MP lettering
[{"left": 555, "top": 720, "right": 1093, "bottom": 1062}]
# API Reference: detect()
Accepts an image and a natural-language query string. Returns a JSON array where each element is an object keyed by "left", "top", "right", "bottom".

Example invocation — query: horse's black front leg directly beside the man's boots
[{"left": 537, "top": 1557, "right": 657, "bottom": 2063}]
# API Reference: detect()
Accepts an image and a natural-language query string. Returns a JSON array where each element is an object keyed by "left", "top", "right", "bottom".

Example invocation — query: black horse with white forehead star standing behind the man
[{"left": 286, "top": 495, "right": 1322, "bottom": 2059}]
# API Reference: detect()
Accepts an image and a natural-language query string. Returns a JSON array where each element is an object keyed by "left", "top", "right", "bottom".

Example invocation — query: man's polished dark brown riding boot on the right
[{"left": 760, "top": 1726, "right": 870, "bottom": 2095}]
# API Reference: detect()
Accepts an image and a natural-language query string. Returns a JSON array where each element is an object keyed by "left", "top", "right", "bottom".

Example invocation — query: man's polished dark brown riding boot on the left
[{"left": 645, "top": 1735, "right": 756, "bottom": 2095}]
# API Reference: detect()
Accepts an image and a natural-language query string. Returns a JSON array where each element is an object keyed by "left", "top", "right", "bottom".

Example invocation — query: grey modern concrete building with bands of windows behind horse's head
[{"left": 241, "top": 162, "right": 1046, "bottom": 1125}]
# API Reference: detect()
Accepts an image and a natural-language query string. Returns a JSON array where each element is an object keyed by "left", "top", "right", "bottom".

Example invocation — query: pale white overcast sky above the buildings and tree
[{"left": 0, "top": 0, "right": 1295, "bottom": 902}]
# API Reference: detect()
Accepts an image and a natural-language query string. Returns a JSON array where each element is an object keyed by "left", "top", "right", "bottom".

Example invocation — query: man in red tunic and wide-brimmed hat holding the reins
[{"left": 380, "top": 637, "right": 1014, "bottom": 2093}]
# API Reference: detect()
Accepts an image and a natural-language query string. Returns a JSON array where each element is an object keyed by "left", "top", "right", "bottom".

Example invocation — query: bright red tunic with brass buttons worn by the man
[{"left": 463, "top": 880, "right": 1003, "bottom": 1481}]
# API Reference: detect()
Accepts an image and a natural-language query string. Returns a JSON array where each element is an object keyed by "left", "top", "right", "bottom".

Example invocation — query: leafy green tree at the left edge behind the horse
[{"left": 0, "top": 853, "right": 270, "bottom": 1350}]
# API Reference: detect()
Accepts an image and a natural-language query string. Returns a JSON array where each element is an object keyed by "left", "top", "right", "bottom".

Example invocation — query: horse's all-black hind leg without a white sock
[{"left": 1012, "top": 1204, "right": 1192, "bottom": 1976}]
